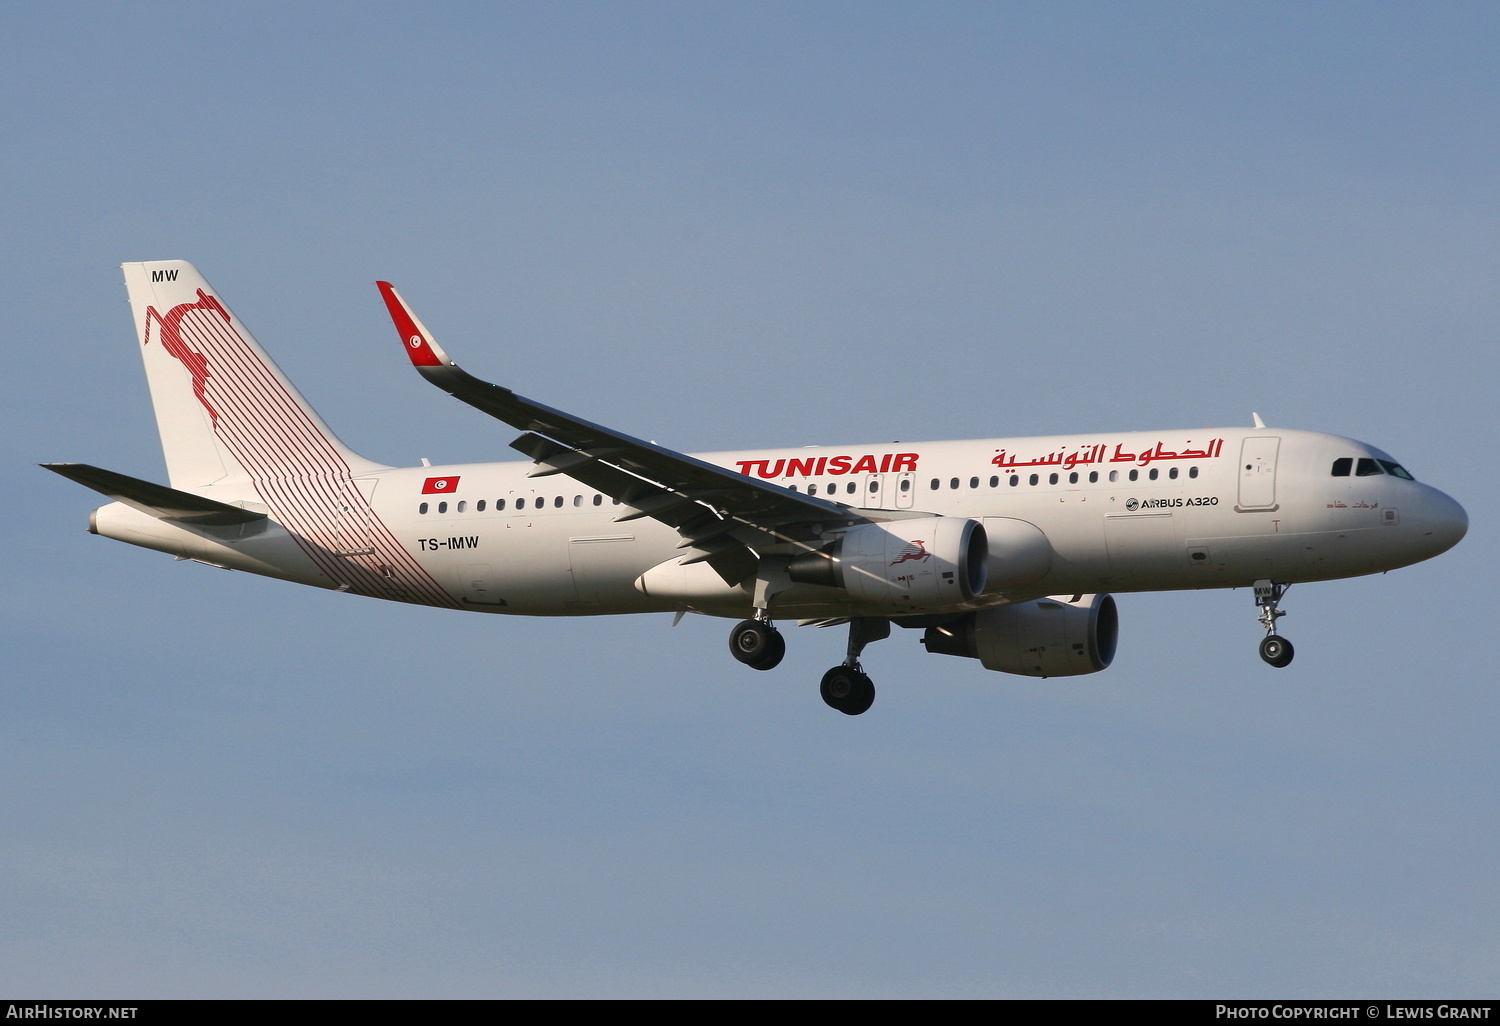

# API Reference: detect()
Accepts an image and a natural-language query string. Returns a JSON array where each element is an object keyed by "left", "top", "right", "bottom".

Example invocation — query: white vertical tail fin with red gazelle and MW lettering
[{"left": 122, "top": 260, "right": 380, "bottom": 498}]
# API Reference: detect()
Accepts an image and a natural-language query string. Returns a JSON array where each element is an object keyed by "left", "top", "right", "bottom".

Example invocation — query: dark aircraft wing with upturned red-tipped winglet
[{"left": 377, "top": 282, "right": 867, "bottom": 584}]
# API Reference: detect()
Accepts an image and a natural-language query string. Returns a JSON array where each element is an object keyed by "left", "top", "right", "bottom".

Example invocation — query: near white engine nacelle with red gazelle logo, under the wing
[{"left": 788, "top": 516, "right": 990, "bottom": 612}]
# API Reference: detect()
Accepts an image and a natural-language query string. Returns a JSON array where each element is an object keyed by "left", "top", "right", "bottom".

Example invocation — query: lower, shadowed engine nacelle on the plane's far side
[{"left": 923, "top": 596, "right": 1119, "bottom": 677}]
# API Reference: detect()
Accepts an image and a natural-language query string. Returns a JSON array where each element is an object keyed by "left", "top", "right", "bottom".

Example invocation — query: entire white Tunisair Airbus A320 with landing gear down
[{"left": 45, "top": 261, "right": 1469, "bottom": 716}]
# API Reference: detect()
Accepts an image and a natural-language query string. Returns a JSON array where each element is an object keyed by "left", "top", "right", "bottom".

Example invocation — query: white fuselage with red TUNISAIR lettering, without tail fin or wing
[{"left": 93, "top": 428, "right": 1467, "bottom": 617}]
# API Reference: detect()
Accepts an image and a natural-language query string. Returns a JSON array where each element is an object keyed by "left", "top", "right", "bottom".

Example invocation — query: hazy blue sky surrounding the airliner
[{"left": 0, "top": 3, "right": 1500, "bottom": 998}]
